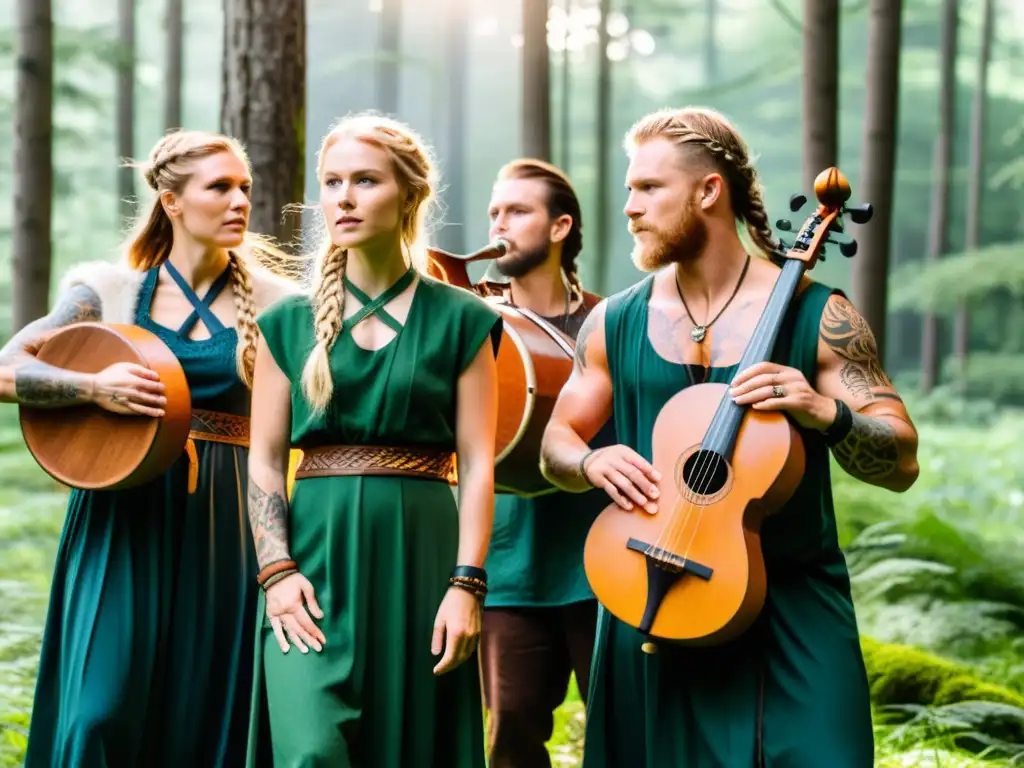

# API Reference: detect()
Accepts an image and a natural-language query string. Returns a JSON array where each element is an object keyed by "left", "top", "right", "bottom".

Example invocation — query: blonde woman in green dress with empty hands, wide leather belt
[{"left": 249, "top": 115, "right": 501, "bottom": 768}]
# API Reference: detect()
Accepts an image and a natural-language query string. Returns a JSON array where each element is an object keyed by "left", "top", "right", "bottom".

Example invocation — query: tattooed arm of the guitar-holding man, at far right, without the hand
[{"left": 816, "top": 295, "right": 919, "bottom": 492}]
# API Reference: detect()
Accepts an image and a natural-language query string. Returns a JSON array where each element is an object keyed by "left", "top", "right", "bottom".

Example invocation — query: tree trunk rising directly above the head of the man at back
[{"left": 521, "top": 0, "right": 551, "bottom": 161}]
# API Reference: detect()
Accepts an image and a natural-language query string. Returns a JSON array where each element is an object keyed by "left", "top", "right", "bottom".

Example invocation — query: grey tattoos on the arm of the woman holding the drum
[{"left": 0, "top": 286, "right": 102, "bottom": 408}]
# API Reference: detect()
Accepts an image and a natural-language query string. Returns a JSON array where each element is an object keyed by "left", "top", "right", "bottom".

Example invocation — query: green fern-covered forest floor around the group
[{"left": 0, "top": 400, "right": 1024, "bottom": 768}]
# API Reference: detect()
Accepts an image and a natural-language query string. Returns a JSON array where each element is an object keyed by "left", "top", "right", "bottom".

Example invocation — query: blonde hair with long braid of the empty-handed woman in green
[{"left": 302, "top": 112, "right": 435, "bottom": 413}]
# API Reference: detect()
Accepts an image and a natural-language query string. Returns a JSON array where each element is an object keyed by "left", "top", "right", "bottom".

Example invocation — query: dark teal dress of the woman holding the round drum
[{"left": 26, "top": 269, "right": 270, "bottom": 768}]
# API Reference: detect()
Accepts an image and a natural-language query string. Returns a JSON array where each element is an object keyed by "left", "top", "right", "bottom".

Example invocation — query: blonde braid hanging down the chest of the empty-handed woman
[{"left": 302, "top": 246, "right": 348, "bottom": 414}]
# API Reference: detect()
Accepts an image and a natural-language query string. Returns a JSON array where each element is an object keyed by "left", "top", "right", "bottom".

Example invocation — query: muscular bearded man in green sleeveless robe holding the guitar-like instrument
[{"left": 542, "top": 108, "right": 918, "bottom": 768}]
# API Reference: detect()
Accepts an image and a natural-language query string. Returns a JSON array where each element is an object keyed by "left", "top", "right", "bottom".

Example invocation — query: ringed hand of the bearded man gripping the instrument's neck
[{"left": 729, "top": 362, "right": 836, "bottom": 430}]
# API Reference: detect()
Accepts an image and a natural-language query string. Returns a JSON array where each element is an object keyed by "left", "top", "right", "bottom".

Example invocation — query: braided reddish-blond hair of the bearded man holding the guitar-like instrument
[{"left": 624, "top": 106, "right": 778, "bottom": 255}]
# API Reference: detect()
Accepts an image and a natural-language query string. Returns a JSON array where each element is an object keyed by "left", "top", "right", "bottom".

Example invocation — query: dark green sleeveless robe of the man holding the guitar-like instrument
[{"left": 584, "top": 276, "right": 873, "bottom": 768}]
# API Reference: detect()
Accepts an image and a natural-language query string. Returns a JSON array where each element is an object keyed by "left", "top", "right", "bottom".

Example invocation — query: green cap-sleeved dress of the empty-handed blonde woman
[{"left": 253, "top": 276, "right": 501, "bottom": 768}]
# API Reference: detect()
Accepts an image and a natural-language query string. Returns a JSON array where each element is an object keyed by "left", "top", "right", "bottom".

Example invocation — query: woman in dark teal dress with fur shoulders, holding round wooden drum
[{"left": 0, "top": 131, "right": 291, "bottom": 768}]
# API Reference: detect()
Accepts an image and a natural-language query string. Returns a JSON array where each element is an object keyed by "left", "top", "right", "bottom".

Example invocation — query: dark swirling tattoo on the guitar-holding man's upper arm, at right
[{"left": 819, "top": 298, "right": 893, "bottom": 400}]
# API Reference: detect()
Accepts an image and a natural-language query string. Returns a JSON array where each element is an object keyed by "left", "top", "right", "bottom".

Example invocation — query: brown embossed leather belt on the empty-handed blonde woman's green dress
[{"left": 295, "top": 445, "right": 458, "bottom": 485}]
